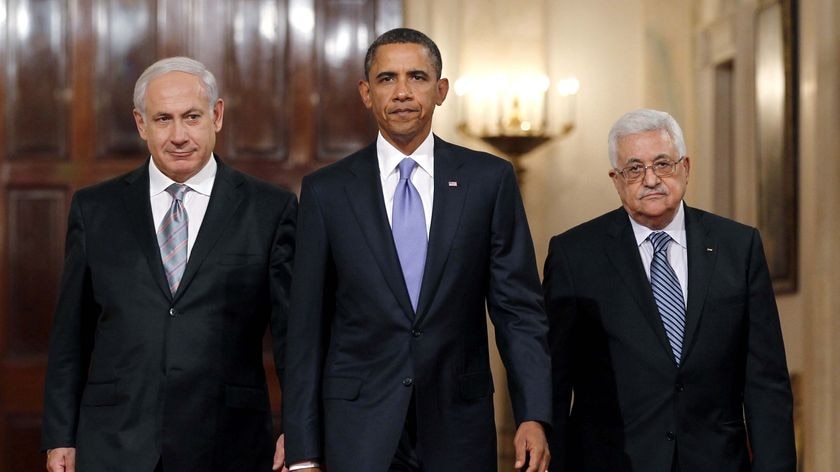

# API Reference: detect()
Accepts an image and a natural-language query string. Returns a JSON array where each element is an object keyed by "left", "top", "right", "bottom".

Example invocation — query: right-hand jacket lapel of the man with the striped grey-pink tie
[{"left": 175, "top": 159, "right": 243, "bottom": 300}]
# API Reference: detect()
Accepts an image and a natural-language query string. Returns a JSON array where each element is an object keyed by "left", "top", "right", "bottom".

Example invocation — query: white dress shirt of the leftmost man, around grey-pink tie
[{"left": 149, "top": 155, "right": 218, "bottom": 259}]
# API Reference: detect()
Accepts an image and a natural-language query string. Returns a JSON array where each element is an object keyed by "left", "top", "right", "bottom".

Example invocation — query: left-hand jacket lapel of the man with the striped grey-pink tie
[{"left": 123, "top": 159, "right": 171, "bottom": 298}]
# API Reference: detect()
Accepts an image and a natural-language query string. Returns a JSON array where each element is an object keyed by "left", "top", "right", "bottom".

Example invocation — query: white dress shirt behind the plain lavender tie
[{"left": 376, "top": 129, "right": 435, "bottom": 238}]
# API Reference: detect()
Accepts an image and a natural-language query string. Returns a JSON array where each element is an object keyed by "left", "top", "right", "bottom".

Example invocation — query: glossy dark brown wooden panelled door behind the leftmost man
[{"left": 0, "top": 0, "right": 402, "bottom": 472}]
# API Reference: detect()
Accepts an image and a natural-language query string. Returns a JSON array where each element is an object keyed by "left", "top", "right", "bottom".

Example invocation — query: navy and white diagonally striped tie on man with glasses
[{"left": 648, "top": 231, "right": 685, "bottom": 366}]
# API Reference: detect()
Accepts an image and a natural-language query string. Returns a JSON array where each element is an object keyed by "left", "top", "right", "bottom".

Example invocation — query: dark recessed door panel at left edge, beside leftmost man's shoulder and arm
[{"left": 3, "top": 189, "right": 67, "bottom": 359}]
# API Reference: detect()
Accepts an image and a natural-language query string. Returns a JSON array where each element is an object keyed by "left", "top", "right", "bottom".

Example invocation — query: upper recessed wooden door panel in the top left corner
[{"left": 4, "top": 0, "right": 70, "bottom": 160}]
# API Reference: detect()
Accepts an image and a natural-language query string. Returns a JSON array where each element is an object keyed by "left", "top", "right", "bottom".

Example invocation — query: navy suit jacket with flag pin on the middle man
[{"left": 283, "top": 138, "right": 551, "bottom": 472}]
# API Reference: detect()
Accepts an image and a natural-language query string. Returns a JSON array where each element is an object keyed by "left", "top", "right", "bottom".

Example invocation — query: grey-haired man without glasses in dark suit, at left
[{"left": 43, "top": 57, "right": 297, "bottom": 472}]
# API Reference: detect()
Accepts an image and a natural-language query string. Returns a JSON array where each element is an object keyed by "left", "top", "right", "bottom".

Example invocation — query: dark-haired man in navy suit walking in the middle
[{"left": 284, "top": 28, "right": 551, "bottom": 472}]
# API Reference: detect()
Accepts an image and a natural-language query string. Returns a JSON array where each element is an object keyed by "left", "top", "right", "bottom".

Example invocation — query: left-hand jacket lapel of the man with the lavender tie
[{"left": 344, "top": 143, "right": 414, "bottom": 319}]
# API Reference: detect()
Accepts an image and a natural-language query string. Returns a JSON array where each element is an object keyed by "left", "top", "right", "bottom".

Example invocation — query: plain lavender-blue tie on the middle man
[{"left": 391, "top": 157, "right": 428, "bottom": 311}]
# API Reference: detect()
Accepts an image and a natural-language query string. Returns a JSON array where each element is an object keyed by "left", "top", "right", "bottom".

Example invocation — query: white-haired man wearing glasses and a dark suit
[{"left": 544, "top": 110, "right": 796, "bottom": 472}]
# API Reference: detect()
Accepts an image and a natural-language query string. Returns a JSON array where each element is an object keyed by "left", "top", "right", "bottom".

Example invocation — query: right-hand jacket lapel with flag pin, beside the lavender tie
[{"left": 417, "top": 136, "right": 469, "bottom": 319}]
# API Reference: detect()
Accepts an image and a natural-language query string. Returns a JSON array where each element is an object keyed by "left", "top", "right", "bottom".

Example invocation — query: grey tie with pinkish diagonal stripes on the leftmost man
[{"left": 157, "top": 184, "right": 190, "bottom": 295}]
